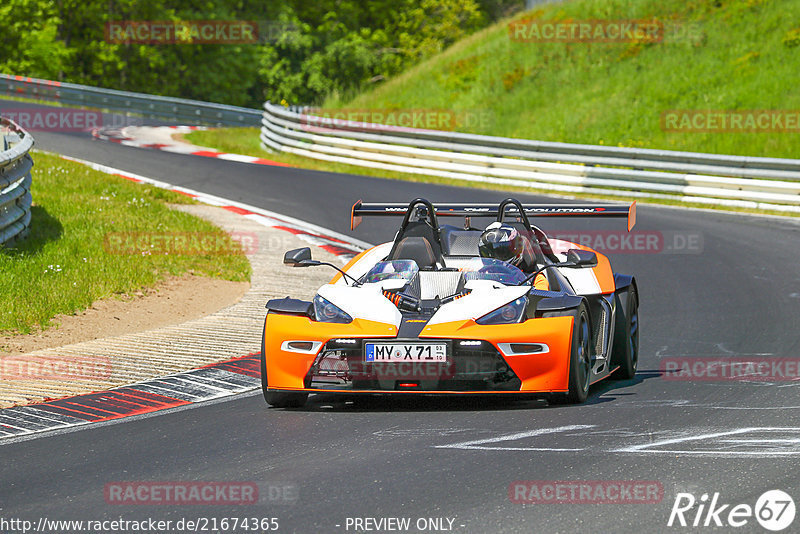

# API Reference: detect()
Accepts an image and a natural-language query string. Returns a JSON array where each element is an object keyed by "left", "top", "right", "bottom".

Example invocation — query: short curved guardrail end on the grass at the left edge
[{"left": 0, "top": 118, "right": 33, "bottom": 245}]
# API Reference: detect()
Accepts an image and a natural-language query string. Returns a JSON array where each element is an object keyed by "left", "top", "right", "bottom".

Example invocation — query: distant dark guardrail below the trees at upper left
[{"left": 0, "top": 74, "right": 261, "bottom": 126}]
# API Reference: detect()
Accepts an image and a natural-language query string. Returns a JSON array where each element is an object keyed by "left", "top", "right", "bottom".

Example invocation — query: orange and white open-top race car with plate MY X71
[{"left": 261, "top": 199, "right": 639, "bottom": 407}]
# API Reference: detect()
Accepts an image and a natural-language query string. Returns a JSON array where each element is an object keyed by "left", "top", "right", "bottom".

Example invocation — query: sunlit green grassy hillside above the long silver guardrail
[{"left": 325, "top": 0, "right": 800, "bottom": 158}]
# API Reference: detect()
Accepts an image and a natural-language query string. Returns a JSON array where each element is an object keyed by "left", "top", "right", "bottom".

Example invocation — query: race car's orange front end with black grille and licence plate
[{"left": 262, "top": 301, "right": 573, "bottom": 394}]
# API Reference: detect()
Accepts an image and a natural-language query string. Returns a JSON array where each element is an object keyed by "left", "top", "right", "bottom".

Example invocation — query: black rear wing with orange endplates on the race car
[{"left": 350, "top": 200, "right": 636, "bottom": 232}]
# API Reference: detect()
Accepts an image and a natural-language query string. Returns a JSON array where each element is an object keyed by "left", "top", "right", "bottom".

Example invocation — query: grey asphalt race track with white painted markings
[{"left": 0, "top": 99, "right": 800, "bottom": 533}]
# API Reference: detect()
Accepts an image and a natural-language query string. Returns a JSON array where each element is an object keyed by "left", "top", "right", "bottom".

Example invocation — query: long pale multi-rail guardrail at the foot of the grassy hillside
[{"left": 260, "top": 102, "right": 800, "bottom": 212}]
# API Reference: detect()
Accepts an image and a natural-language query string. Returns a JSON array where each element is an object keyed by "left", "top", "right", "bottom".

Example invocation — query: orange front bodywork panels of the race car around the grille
[{"left": 265, "top": 313, "right": 573, "bottom": 394}]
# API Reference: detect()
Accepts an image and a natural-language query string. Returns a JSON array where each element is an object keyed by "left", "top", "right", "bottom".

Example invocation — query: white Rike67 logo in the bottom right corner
[{"left": 667, "top": 490, "right": 795, "bottom": 532}]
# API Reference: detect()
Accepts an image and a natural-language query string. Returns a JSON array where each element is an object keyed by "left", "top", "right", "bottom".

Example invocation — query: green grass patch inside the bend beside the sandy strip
[{"left": 0, "top": 152, "right": 250, "bottom": 334}]
